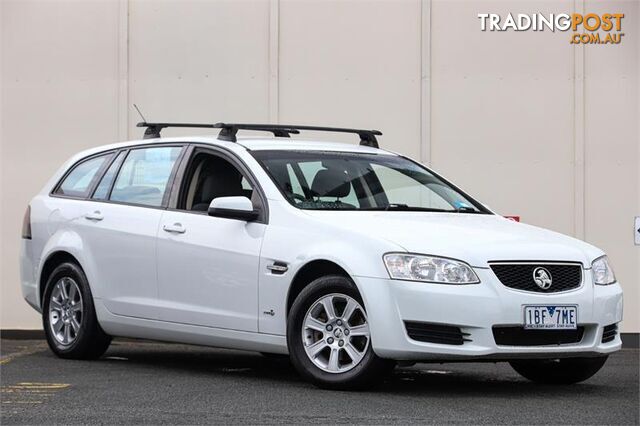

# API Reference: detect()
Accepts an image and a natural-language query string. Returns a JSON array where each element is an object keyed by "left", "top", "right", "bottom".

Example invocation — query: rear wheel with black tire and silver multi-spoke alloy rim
[{"left": 42, "top": 262, "right": 111, "bottom": 359}]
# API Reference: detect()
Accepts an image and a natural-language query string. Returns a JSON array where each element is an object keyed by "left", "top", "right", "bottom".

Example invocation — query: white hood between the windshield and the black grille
[{"left": 306, "top": 210, "right": 604, "bottom": 268}]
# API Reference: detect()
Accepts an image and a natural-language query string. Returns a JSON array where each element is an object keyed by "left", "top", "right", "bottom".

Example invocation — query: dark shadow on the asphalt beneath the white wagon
[{"left": 100, "top": 342, "right": 611, "bottom": 398}]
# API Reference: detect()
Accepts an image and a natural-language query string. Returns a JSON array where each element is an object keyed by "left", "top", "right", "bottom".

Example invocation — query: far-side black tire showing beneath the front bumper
[{"left": 509, "top": 356, "right": 608, "bottom": 385}]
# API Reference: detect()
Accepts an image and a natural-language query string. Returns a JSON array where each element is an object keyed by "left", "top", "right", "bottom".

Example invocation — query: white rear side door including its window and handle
[{"left": 82, "top": 146, "right": 183, "bottom": 319}]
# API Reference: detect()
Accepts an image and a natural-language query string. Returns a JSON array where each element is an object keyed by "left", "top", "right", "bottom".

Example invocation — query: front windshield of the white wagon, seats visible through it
[{"left": 252, "top": 151, "right": 488, "bottom": 213}]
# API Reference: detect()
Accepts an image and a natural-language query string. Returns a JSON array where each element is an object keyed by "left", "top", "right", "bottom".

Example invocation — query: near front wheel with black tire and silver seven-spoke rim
[{"left": 287, "top": 275, "right": 395, "bottom": 390}]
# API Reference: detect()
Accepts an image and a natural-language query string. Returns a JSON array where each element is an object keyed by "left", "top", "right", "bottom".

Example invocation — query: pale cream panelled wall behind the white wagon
[{"left": 0, "top": 0, "right": 640, "bottom": 332}]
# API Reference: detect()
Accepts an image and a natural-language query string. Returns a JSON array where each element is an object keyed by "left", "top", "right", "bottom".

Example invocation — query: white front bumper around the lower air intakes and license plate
[{"left": 356, "top": 268, "right": 622, "bottom": 361}]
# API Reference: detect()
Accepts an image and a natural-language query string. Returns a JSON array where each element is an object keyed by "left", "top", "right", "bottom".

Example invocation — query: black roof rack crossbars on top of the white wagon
[{"left": 137, "top": 121, "right": 382, "bottom": 148}]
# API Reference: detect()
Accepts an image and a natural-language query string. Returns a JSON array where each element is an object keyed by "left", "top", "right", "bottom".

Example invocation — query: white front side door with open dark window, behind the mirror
[{"left": 158, "top": 148, "right": 266, "bottom": 331}]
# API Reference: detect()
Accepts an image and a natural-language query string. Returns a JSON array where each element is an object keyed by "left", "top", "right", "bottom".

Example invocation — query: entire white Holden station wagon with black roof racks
[{"left": 21, "top": 123, "right": 622, "bottom": 389}]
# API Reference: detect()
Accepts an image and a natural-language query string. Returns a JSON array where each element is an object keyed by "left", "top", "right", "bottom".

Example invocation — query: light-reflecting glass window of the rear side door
[{"left": 109, "top": 147, "right": 182, "bottom": 207}]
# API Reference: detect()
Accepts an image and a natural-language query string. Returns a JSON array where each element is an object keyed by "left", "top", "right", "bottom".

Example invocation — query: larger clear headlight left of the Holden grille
[{"left": 384, "top": 253, "right": 480, "bottom": 284}]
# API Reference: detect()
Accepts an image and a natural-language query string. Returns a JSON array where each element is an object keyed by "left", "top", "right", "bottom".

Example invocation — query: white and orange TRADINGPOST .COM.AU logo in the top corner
[{"left": 478, "top": 13, "right": 624, "bottom": 44}]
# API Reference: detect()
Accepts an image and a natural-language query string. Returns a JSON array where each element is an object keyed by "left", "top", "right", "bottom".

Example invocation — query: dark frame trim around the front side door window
[{"left": 167, "top": 144, "right": 269, "bottom": 224}]
